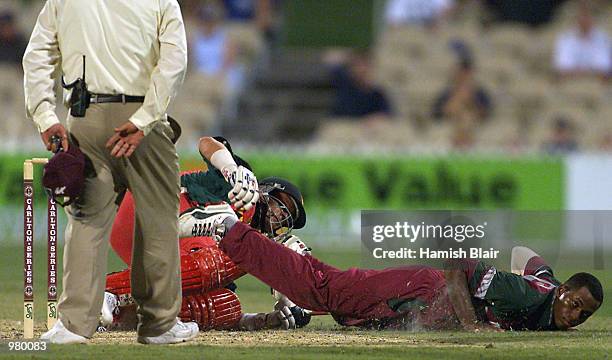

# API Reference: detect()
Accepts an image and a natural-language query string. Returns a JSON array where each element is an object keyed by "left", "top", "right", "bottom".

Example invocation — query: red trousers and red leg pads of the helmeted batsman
[{"left": 106, "top": 192, "right": 244, "bottom": 330}]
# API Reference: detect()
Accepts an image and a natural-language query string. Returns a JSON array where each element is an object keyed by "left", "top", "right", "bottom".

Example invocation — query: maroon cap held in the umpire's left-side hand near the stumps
[{"left": 42, "top": 144, "right": 85, "bottom": 206}]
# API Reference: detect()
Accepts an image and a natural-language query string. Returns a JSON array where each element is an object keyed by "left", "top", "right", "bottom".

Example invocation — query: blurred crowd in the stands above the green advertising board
[{"left": 0, "top": 0, "right": 612, "bottom": 154}]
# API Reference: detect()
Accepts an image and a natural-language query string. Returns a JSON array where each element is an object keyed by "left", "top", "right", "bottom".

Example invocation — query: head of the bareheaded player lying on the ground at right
[{"left": 553, "top": 285, "right": 601, "bottom": 330}]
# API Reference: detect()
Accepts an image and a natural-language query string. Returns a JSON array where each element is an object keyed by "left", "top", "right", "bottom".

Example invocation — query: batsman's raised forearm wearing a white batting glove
[{"left": 198, "top": 137, "right": 259, "bottom": 211}]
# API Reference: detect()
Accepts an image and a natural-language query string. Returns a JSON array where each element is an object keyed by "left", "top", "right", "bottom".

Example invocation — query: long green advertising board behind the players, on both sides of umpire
[{"left": 0, "top": 152, "right": 565, "bottom": 246}]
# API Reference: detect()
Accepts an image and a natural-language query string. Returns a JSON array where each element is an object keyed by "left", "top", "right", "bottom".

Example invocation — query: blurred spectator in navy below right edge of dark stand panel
[{"left": 325, "top": 49, "right": 392, "bottom": 119}]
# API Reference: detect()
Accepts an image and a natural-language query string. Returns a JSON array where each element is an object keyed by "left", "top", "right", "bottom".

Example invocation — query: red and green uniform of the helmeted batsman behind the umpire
[{"left": 106, "top": 171, "right": 255, "bottom": 330}]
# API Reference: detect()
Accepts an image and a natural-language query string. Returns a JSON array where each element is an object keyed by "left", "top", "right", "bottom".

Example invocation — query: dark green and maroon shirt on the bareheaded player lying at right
[{"left": 464, "top": 256, "right": 560, "bottom": 330}]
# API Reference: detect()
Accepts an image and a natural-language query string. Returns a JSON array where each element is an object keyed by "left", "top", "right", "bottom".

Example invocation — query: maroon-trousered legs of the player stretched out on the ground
[{"left": 219, "top": 223, "right": 452, "bottom": 319}]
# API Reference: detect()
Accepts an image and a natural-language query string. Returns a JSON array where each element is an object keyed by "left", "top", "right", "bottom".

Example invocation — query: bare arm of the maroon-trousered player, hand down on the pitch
[{"left": 444, "top": 260, "right": 499, "bottom": 331}]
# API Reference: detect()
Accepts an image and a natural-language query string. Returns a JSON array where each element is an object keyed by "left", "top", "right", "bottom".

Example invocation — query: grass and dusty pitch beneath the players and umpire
[{"left": 0, "top": 242, "right": 612, "bottom": 360}]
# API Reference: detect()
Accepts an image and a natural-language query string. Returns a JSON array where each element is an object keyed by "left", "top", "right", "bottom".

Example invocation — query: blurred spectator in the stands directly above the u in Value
[{"left": 433, "top": 58, "right": 492, "bottom": 123}]
